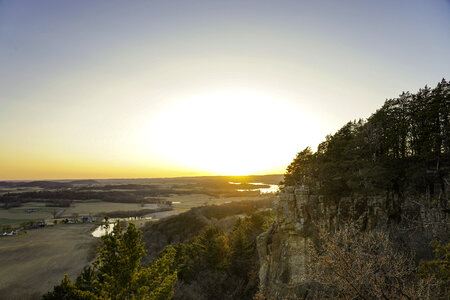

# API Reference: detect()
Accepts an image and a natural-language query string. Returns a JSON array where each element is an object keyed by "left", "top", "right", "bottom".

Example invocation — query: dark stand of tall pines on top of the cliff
[{"left": 283, "top": 79, "right": 450, "bottom": 199}]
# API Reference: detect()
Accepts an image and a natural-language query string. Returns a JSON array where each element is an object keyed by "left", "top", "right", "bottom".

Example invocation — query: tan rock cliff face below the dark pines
[{"left": 257, "top": 187, "right": 449, "bottom": 299}]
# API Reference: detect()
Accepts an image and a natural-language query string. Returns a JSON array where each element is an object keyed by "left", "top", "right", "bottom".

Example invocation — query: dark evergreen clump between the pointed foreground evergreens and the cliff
[{"left": 169, "top": 211, "right": 272, "bottom": 300}]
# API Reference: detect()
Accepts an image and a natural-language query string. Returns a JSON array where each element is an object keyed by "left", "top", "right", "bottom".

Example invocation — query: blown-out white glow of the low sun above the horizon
[{"left": 147, "top": 90, "right": 320, "bottom": 175}]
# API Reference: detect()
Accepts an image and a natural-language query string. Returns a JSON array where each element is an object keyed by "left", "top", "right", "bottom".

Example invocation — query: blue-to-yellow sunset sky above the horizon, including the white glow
[{"left": 0, "top": 0, "right": 450, "bottom": 180}]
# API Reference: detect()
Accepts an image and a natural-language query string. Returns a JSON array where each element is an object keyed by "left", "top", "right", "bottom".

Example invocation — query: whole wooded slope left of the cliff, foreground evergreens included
[{"left": 43, "top": 200, "right": 272, "bottom": 300}]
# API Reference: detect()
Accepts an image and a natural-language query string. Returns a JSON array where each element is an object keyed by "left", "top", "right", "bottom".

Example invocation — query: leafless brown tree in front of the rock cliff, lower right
[{"left": 307, "top": 225, "right": 436, "bottom": 299}]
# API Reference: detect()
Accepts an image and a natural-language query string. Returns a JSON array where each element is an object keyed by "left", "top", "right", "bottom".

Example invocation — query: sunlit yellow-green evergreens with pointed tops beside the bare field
[{"left": 43, "top": 222, "right": 177, "bottom": 300}]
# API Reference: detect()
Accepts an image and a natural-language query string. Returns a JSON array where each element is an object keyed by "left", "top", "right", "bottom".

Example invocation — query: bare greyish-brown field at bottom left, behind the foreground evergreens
[{"left": 0, "top": 224, "right": 98, "bottom": 299}]
